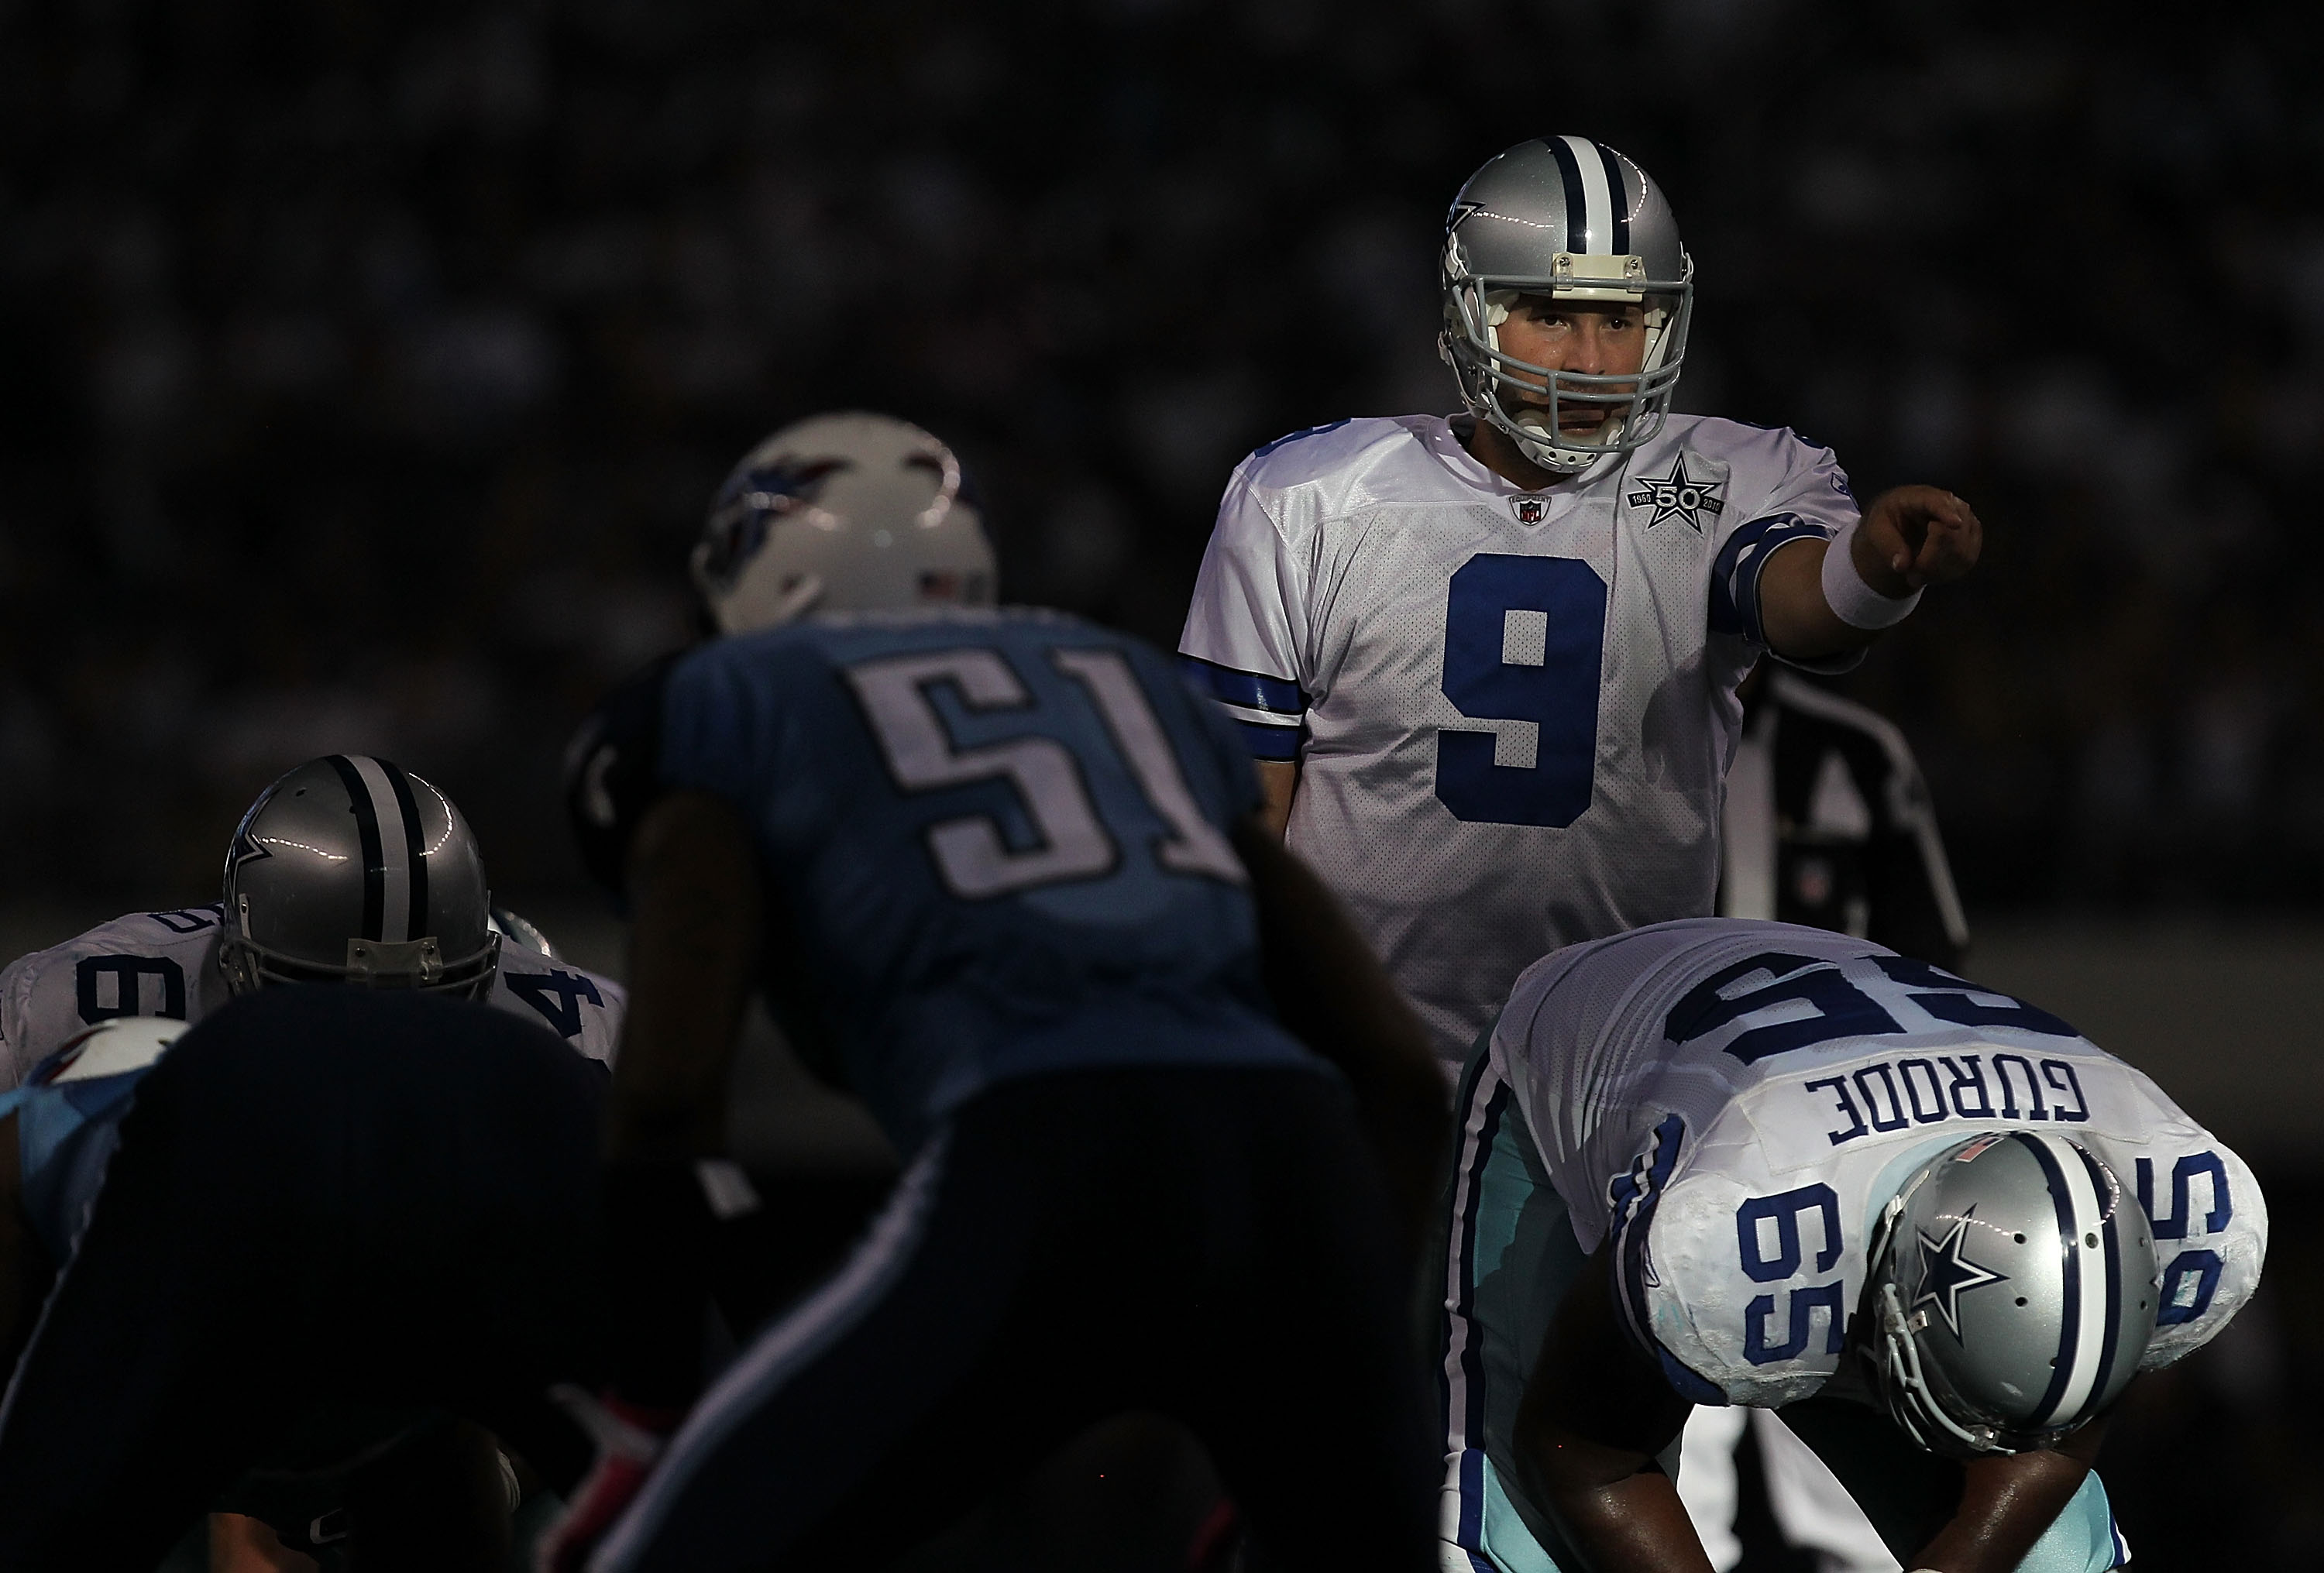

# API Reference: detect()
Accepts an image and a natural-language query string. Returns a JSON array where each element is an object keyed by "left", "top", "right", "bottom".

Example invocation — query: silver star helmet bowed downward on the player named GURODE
[{"left": 1864, "top": 1132, "right": 2159, "bottom": 1457}]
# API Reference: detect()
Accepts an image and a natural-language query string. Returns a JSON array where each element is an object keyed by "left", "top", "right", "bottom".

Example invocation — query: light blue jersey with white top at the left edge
[{"left": 0, "top": 1018, "right": 186, "bottom": 1266}]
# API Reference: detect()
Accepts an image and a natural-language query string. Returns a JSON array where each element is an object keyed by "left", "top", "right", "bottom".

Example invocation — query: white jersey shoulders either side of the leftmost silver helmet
[{"left": 0, "top": 902, "right": 627, "bottom": 1092}]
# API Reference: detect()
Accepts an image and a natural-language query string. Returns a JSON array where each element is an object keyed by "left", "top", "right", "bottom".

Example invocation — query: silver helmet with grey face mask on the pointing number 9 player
[{"left": 1436, "top": 137, "right": 1694, "bottom": 474}]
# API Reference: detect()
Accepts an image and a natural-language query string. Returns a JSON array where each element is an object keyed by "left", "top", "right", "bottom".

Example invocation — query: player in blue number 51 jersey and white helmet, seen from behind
[{"left": 544, "top": 416, "right": 1443, "bottom": 1573}]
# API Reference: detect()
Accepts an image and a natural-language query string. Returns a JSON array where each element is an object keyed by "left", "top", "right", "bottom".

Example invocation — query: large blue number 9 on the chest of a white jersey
[{"left": 1436, "top": 553, "right": 1606, "bottom": 827}]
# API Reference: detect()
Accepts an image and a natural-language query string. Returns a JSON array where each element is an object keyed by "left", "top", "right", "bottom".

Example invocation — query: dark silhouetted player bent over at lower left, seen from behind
[{"left": 0, "top": 990, "right": 607, "bottom": 1573}]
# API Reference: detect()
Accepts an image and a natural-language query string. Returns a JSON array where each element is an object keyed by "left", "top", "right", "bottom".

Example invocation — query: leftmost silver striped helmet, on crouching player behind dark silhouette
[{"left": 218, "top": 753, "right": 500, "bottom": 999}]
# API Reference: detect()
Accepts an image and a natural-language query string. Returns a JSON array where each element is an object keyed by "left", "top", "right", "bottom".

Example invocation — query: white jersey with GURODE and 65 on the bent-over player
[{"left": 1487, "top": 920, "right": 2268, "bottom": 1406}]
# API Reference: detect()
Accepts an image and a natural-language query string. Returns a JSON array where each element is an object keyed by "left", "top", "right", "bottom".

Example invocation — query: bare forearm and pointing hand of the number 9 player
[{"left": 1759, "top": 486, "right": 1985, "bottom": 660}]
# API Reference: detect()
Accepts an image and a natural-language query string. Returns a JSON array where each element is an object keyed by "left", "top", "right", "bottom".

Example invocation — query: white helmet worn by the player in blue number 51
[{"left": 693, "top": 411, "right": 992, "bottom": 634}]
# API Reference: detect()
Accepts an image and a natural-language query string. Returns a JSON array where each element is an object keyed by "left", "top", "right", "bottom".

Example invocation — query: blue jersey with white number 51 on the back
[{"left": 658, "top": 609, "right": 1318, "bottom": 1150}]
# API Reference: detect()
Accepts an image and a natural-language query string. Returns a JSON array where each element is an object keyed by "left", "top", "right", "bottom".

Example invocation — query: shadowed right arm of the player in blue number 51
[{"left": 1234, "top": 811, "right": 1450, "bottom": 1248}]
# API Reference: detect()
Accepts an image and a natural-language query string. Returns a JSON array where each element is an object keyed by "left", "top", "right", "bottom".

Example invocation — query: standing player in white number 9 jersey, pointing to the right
[{"left": 1178, "top": 137, "right": 1980, "bottom": 1076}]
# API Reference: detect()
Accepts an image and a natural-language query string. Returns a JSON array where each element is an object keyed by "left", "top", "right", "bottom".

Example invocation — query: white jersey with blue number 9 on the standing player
[{"left": 1178, "top": 416, "right": 1857, "bottom": 1073}]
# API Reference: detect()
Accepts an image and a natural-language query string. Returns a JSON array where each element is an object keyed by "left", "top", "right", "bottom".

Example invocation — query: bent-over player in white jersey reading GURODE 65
[{"left": 1439, "top": 918, "right": 2268, "bottom": 1573}]
